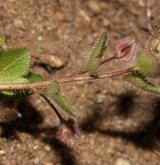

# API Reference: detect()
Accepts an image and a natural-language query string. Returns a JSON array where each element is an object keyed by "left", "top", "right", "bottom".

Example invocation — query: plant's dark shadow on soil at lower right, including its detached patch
[{"left": 81, "top": 92, "right": 160, "bottom": 151}]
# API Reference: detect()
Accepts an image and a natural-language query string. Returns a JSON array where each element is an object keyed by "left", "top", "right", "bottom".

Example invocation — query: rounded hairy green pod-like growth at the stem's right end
[{"left": 137, "top": 52, "right": 160, "bottom": 78}]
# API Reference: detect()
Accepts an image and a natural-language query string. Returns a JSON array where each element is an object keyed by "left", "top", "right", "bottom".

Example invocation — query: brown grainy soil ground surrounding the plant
[{"left": 0, "top": 0, "right": 160, "bottom": 165}]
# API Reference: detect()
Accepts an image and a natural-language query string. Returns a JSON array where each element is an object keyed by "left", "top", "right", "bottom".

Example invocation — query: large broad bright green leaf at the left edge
[{"left": 0, "top": 48, "right": 30, "bottom": 84}]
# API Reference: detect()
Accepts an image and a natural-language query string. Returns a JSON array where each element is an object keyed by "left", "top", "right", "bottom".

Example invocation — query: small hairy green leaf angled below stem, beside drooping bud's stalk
[{"left": 53, "top": 95, "right": 75, "bottom": 116}]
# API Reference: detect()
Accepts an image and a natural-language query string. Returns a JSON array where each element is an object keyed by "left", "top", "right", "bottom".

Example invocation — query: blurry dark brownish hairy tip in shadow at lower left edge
[{"left": 0, "top": 107, "right": 21, "bottom": 123}]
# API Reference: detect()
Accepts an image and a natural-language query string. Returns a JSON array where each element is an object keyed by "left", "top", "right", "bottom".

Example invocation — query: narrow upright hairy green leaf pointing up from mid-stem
[{"left": 86, "top": 32, "right": 107, "bottom": 73}]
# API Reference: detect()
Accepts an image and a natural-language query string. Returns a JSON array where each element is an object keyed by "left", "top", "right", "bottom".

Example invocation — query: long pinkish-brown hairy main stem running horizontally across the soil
[{"left": 0, "top": 67, "right": 135, "bottom": 91}]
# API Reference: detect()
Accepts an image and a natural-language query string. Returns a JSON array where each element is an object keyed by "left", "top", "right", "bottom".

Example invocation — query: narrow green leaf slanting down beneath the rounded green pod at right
[{"left": 124, "top": 72, "right": 160, "bottom": 94}]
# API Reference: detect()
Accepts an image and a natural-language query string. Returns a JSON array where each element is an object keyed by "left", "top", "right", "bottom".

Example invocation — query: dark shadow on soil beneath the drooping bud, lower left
[{"left": 1, "top": 100, "right": 77, "bottom": 165}]
